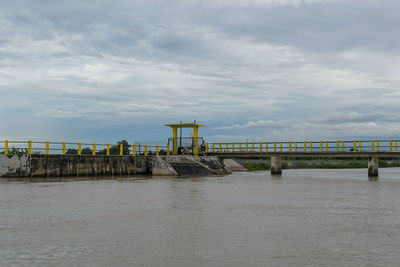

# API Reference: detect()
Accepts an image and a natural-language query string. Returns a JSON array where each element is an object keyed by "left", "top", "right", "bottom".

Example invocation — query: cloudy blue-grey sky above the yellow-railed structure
[{"left": 0, "top": 0, "right": 400, "bottom": 142}]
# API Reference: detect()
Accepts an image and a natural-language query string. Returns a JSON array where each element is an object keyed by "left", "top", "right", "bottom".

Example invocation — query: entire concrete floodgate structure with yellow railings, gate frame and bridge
[{"left": 0, "top": 122, "right": 400, "bottom": 178}]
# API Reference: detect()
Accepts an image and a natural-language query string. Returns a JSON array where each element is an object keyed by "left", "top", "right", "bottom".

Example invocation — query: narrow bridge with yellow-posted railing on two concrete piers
[{"left": 205, "top": 140, "right": 400, "bottom": 177}]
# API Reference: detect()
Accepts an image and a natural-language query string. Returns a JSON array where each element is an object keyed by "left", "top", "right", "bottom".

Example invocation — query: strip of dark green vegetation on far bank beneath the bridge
[{"left": 241, "top": 159, "right": 400, "bottom": 171}]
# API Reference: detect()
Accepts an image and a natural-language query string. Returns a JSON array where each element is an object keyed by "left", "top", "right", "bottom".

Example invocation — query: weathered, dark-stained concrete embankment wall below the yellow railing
[{"left": 0, "top": 155, "right": 229, "bottom": 177}]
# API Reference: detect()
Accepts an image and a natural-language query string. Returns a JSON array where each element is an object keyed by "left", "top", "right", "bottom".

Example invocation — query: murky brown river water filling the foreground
[{"left": 0, "top": 168, "right": 400, "bottom": 266}]
